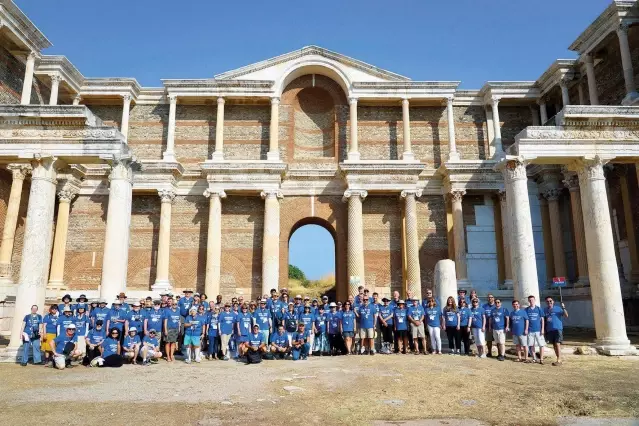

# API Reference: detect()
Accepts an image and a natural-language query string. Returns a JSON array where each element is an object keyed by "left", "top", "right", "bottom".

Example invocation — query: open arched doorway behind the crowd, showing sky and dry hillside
[{"left": 286, "top": 217, "right": 338, "bottom": 300}]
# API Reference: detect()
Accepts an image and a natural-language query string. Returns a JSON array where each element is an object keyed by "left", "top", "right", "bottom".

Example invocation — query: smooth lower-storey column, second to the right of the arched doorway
[{"left": 401, "top": 189, "right": 422, "bottom": 300}]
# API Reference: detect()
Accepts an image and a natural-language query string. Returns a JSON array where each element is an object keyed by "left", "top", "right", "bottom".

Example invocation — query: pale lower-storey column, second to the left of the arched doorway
[{"left": 204, "top": 189, "right": 226, "bottom": 300}]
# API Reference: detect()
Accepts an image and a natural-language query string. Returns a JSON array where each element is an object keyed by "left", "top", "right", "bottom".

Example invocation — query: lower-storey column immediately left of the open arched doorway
[{"left": 261, "top": 189, "right": 283, "bottom": 295}]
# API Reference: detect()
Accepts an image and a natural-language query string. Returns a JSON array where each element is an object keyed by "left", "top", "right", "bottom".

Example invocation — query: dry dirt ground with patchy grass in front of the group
[{"left": 0, "top": 355, "right": 639, "bottom": 425}]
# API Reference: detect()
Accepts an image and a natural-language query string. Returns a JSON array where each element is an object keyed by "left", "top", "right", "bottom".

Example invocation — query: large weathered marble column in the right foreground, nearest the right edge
[{"left": 576, "top": 157, "right": 636, "bottom": 355}]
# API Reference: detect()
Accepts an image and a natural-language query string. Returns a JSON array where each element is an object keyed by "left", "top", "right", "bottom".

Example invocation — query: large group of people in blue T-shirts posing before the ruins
[{"left": 16, "top": 287, "right": 568, "bottom": 369}]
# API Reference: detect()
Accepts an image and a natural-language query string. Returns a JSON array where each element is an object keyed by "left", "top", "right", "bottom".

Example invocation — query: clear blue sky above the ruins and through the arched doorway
[{"left": 16, "top": 0, "right": 610, "bottom": 279}]
